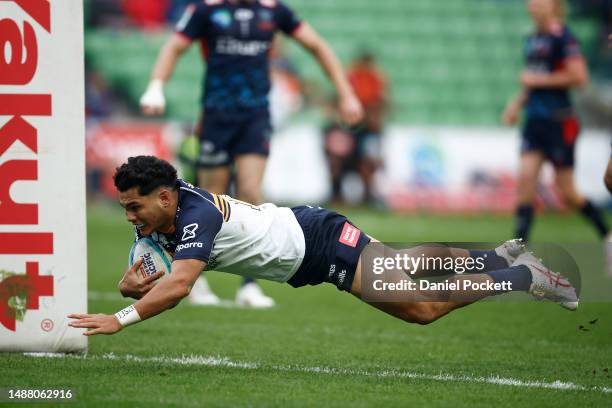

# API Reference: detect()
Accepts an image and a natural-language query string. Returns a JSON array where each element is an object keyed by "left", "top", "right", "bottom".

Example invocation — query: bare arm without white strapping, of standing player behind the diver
[{"left": 293, "top": 22, "right": 363, "bottom": 125}]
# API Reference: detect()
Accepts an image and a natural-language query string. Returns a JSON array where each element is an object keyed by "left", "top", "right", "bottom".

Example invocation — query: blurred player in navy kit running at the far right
[{"left": 502, "top": 0, "right": 608, "bottom": 240}]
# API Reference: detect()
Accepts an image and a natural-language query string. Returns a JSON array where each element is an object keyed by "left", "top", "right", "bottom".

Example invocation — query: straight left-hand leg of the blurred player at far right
[{"left": 514, "top": 150, "right": 544, "bottom": 241}]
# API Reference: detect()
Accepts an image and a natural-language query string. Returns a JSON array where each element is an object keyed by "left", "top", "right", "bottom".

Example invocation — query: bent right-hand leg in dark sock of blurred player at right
[{"left": 555, "top": 167, "right": 608, "bottom": 238}]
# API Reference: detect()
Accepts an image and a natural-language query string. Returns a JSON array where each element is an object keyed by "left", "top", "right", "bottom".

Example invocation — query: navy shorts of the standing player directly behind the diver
[{"left": 198, "top": 108, "right": 272, "bottom": 168}]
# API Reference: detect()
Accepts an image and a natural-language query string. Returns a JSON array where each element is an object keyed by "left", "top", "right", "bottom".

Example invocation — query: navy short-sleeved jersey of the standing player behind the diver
[{"left": 176, "top": 0, "right": 300, "bottom": 111}]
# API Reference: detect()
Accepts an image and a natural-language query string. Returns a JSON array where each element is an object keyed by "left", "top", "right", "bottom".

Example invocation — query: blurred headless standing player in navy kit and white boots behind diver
[{"left": 141, "top": 0, "right": 362, "bottom": 307}]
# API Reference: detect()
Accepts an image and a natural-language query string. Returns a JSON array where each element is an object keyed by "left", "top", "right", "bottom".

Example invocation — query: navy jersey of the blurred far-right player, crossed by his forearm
[{"left": 525, "top": 26, "right": 582, "bottom": 119}]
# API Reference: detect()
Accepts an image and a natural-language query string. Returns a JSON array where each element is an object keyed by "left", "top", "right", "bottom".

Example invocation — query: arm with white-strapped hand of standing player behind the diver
[{"left": 140, "top": 34, "right": 191, "bottom": 115}]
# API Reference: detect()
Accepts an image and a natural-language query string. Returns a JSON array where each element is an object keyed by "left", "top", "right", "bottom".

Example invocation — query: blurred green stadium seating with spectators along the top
[{"left": 85, "top": 0, "right": 612, "bottom": 124}]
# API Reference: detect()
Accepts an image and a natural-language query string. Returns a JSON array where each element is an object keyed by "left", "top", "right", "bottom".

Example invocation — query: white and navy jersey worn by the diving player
[{"left": 142, "top": 180, "right": 306, "bottom": 282}]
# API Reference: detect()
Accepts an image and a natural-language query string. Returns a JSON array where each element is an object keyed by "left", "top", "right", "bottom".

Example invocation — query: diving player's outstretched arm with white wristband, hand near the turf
[{"left": 68, "top": 259, "right": 206, "bottom": 336}]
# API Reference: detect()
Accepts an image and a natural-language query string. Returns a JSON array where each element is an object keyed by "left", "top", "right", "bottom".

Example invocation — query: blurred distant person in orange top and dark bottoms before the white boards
[{"left": 323, "top": 49, "right": 388, "bottom": 203}]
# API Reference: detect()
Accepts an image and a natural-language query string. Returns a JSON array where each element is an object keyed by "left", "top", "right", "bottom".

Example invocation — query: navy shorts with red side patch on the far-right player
[{"left": 521, "top": 117, "right": 580, "bottom": 168}]
